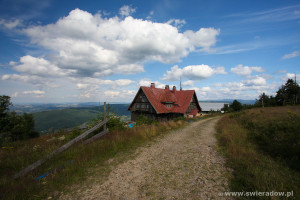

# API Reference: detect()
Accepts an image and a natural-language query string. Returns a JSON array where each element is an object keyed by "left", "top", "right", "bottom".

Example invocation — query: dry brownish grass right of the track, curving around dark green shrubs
[{"left": 217, "top": 106, "right": 300, "bottom": 199}]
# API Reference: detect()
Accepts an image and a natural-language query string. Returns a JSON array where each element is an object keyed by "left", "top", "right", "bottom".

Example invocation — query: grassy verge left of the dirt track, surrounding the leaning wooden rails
[{"left": 0, "top": 120, "right": 190, "bottom": 199}]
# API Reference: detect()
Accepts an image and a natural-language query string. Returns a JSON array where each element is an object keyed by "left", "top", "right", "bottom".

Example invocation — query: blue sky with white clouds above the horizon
[{"left": 0, "top": 0, "right": 300, "bottom": 103}]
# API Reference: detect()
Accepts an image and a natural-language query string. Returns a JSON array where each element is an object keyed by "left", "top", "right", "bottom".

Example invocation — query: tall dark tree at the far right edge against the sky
[{"left": 275, "top": 79, "right": 300, "bottom": 106}]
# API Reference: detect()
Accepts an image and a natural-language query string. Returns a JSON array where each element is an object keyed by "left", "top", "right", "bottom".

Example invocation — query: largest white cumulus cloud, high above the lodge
[{"left": 23, "top": 9, "right": 220, "bottom": 77}]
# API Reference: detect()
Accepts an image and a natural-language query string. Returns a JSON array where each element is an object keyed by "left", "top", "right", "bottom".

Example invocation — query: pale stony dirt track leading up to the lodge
[{"left": 61, "top": 118, "right": 229, "bottom": 200}]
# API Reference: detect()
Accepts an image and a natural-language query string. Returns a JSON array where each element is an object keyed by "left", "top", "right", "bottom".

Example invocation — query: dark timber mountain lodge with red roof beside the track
[{"left": 128, "top": 83, "right": 201, "bottom": 121}]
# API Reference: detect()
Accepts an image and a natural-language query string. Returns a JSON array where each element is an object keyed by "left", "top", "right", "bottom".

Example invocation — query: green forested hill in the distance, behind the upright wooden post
[{"left": 32, "top": 104, "right": 130, "bottom": 132}]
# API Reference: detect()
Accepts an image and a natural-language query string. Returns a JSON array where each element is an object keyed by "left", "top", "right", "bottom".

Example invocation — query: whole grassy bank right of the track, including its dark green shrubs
[{"left": 217, "top": 106, "right": 300, "bottom": 199}]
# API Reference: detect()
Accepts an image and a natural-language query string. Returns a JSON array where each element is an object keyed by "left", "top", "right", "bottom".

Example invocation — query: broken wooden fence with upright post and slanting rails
[{"left": 13, "top": 102, "right": 108, "bottom": 179}]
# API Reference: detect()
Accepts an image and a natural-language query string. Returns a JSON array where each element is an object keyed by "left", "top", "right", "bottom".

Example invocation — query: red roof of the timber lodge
[{"left": 128, "top": 86, "right": 201, "bottom": 114}]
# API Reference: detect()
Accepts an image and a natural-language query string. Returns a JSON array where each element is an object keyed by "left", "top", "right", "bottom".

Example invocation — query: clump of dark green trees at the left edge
[{"left": 0, "top": 95, "right": 39, "bottom": 145}]
